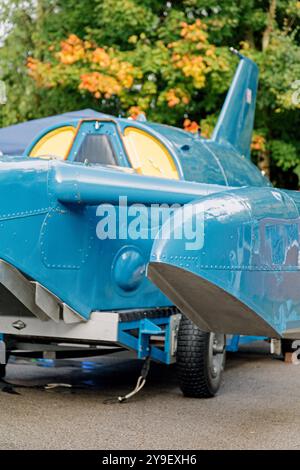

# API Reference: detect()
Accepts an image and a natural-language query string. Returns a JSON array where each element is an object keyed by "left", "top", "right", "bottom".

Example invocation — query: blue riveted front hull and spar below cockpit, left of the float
[{"left": 0, "top": 158, "right": 230, "bottom": 318}]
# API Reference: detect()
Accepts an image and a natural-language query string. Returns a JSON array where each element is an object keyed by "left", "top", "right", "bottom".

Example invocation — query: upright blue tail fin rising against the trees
[{"left": 212, "top": 49, "right": 258, "bottom": 158}]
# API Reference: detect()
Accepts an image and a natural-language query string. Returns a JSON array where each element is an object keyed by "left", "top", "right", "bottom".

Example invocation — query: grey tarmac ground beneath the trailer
[{"left": 0, "top": 343, "right": 300, "bottom": 450}]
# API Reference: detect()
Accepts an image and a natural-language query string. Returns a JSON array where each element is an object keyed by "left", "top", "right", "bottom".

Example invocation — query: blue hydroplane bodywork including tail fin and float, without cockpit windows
[{"left": 0, "top": 51, "right": 300, "bottom": 354}]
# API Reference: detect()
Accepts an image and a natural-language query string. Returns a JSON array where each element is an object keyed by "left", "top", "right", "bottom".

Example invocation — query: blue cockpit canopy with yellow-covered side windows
[{"left": 25, "top": 117, "right": 268, "bottom": 186}]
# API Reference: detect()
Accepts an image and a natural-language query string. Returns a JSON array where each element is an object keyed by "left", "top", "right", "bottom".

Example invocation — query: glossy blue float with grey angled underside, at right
[{"left": 148, "top": 187, "right": 300, "bottom": 337}]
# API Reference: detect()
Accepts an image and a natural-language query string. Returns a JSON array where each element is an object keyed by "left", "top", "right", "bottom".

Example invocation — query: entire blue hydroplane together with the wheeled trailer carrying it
[{"left": 0, "top": 49, "right": 292, "bottom": 397}]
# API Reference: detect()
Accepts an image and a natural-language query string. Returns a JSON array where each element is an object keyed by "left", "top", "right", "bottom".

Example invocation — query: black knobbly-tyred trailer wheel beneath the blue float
[{"left": 177, "top": 316, "right": 226, "bottom": 398}]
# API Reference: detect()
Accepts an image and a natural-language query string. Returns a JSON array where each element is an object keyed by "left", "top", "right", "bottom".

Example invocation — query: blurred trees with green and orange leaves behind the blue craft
[{"left": 0, "top": 0, "right": 300, "bottom": 188}]
